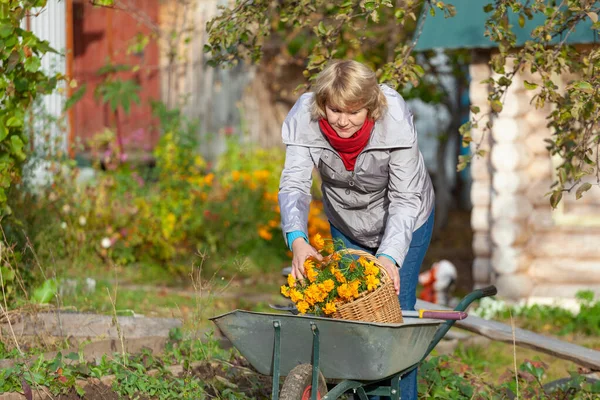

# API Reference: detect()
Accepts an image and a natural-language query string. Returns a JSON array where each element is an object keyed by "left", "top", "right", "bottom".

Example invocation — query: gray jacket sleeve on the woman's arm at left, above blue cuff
[{"left": 279, "top": 145, "right": 314, "bottom": 247}]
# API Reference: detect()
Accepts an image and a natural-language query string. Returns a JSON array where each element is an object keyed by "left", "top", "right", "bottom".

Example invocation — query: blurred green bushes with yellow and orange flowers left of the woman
[{"left": 3, "top": 99, "right": 286, "bottom": 275}]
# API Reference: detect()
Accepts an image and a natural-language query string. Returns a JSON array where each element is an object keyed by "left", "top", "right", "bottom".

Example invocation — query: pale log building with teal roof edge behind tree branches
[{"left": 416, "top": 0, "right": 600, "bottom": 301}]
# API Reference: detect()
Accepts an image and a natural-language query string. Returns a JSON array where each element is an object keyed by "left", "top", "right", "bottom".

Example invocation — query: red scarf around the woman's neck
[{"left": 319, "top": 118, "right": 375, "bottom": 171}]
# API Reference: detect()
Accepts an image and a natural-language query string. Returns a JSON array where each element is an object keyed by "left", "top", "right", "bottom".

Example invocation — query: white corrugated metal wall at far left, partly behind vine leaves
[{"left": 23, "top": 0, "right": 68, "bottom": 152}]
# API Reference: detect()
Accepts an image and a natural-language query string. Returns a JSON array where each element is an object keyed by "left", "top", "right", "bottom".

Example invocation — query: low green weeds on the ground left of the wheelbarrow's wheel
[{"left": 0, "top": 334, "right": 267, "bottom": 399}]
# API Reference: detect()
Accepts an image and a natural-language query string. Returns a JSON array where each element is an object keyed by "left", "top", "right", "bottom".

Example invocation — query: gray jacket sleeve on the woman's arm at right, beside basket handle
[{"left": 377, "top": 141, "right": 427, "bottom": 267}]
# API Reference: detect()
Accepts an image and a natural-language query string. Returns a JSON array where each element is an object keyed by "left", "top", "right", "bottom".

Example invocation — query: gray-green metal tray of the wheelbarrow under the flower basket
[{"left": 211, "top": 310, "right": 444, "bottom": 380}]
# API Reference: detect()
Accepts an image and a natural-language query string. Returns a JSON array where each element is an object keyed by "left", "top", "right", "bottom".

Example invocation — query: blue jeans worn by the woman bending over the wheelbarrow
[{"left": 329, "top": 210, "right": 435, "bottom": 400}]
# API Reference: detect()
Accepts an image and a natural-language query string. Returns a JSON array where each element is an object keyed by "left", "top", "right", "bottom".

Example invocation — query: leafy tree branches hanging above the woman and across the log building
[{"left": 205, "top": 0, "right": 600, "bottom": 206}]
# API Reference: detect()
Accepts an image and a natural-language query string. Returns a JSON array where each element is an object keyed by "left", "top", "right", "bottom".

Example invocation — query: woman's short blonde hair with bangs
[{"left": 310, "top": 60, "right": 387, "bottom": 121}]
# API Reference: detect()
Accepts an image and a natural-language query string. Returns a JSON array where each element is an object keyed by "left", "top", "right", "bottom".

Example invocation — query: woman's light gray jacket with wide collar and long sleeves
[{"left": 279, "top": 85, "right": 435, "bottom": 266}]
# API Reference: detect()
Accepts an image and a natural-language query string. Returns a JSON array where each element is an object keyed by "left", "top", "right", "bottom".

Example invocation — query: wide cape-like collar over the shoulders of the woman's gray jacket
[{"left": 282, "top": 85, "right": 417, "bottom": 151}]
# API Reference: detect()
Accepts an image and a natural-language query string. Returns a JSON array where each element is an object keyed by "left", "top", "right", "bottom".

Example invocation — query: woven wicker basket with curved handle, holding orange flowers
[{"left": 332, "top": 249, "right": 403, "bottom": 323}]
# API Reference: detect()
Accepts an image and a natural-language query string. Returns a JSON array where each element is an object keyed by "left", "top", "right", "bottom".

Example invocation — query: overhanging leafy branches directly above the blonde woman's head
[{"left": 204, "top": 0, "right": 454, "bottom": 86}]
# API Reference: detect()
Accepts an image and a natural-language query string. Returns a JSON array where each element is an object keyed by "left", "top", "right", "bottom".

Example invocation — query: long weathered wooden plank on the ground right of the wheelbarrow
[{"left": 415, "top": 300, "right": 600, "bottom": 371}]
